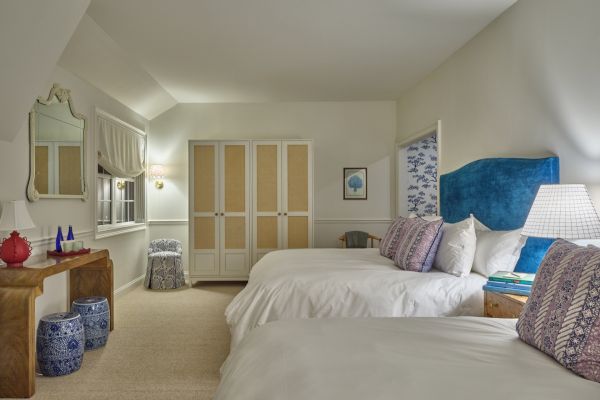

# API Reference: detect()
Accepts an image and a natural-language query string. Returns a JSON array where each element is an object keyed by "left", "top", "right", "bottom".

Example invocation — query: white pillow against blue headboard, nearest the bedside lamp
[{"left": 473, "top": 229, "right": 527, "bottom": 278}]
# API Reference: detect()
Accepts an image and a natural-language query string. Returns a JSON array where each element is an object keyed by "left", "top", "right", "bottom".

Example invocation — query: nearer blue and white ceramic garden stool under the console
[{"left": 36, "top": 312, "right": 85, "bottom": 376}]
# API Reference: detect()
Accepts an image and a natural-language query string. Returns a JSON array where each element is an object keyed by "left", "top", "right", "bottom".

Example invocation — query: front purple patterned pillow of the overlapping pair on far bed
[{"left": 394, "top": 218, "right": 444, "bottom": 272}]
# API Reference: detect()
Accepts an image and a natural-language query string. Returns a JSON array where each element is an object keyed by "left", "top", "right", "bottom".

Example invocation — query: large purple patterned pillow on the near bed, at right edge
[{"left": 517, "top": 240, "right": 600, "bottom": 382}]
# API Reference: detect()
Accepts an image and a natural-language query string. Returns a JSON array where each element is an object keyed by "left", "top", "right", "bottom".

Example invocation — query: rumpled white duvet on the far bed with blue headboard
[{"left": 225, "top": 249, "right": 486, "bottom": 348}]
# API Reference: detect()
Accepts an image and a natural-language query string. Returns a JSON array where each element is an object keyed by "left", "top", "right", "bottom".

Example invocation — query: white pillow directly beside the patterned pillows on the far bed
[{"left": 433, "top": 216, "right": 477, "bottom": 276}]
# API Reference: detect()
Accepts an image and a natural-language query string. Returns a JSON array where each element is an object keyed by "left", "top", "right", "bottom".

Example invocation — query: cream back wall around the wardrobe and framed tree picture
[{"left": 148, "top": 101, "right": 396, "bottom": 265}]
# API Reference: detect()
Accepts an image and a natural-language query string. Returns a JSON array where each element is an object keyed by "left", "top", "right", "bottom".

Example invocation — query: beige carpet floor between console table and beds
[{"left": 33, "top": 283, "right": 243, "bottom": 400}]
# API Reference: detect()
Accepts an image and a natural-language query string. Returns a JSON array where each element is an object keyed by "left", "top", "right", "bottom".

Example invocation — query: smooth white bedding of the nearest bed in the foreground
[{"left": 215, "top": 317, "right": 600, "bottom": 400}]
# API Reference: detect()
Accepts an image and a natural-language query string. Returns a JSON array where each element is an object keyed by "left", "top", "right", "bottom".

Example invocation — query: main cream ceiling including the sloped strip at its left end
[{"left": 74, "top": 0, "right": 515, "bottom": 104}]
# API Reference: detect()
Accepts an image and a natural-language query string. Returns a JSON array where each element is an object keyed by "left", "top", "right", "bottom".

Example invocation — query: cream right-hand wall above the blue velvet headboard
[{"left": 397, "top": 0, "right": 600, "bottom": 205}]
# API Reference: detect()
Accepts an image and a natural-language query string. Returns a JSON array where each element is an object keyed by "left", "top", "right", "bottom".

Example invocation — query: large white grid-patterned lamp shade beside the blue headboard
[{"left": 521, "top": 185, "right": 600, "bottom": 240}]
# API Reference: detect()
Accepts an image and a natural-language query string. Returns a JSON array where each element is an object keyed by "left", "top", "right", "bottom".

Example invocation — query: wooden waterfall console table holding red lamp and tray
[{"left": 0, "top": 250, "right": 115, "bottom": 398}]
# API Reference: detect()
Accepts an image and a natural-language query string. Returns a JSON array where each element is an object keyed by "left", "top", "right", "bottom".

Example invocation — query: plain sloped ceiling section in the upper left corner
[{"left": 0, "top": 0, "right": 90, "bottom": 141}]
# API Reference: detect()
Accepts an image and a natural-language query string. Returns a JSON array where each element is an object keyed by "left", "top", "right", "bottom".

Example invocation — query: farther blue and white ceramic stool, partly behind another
[{"left": 71, "top": 297, "right": 110, "bottom": 351}]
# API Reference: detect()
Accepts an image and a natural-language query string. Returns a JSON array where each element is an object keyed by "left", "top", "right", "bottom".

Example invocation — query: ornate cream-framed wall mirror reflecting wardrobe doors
[{"left": 27, "top": 83, "right": 88, "bottom": 201}]
